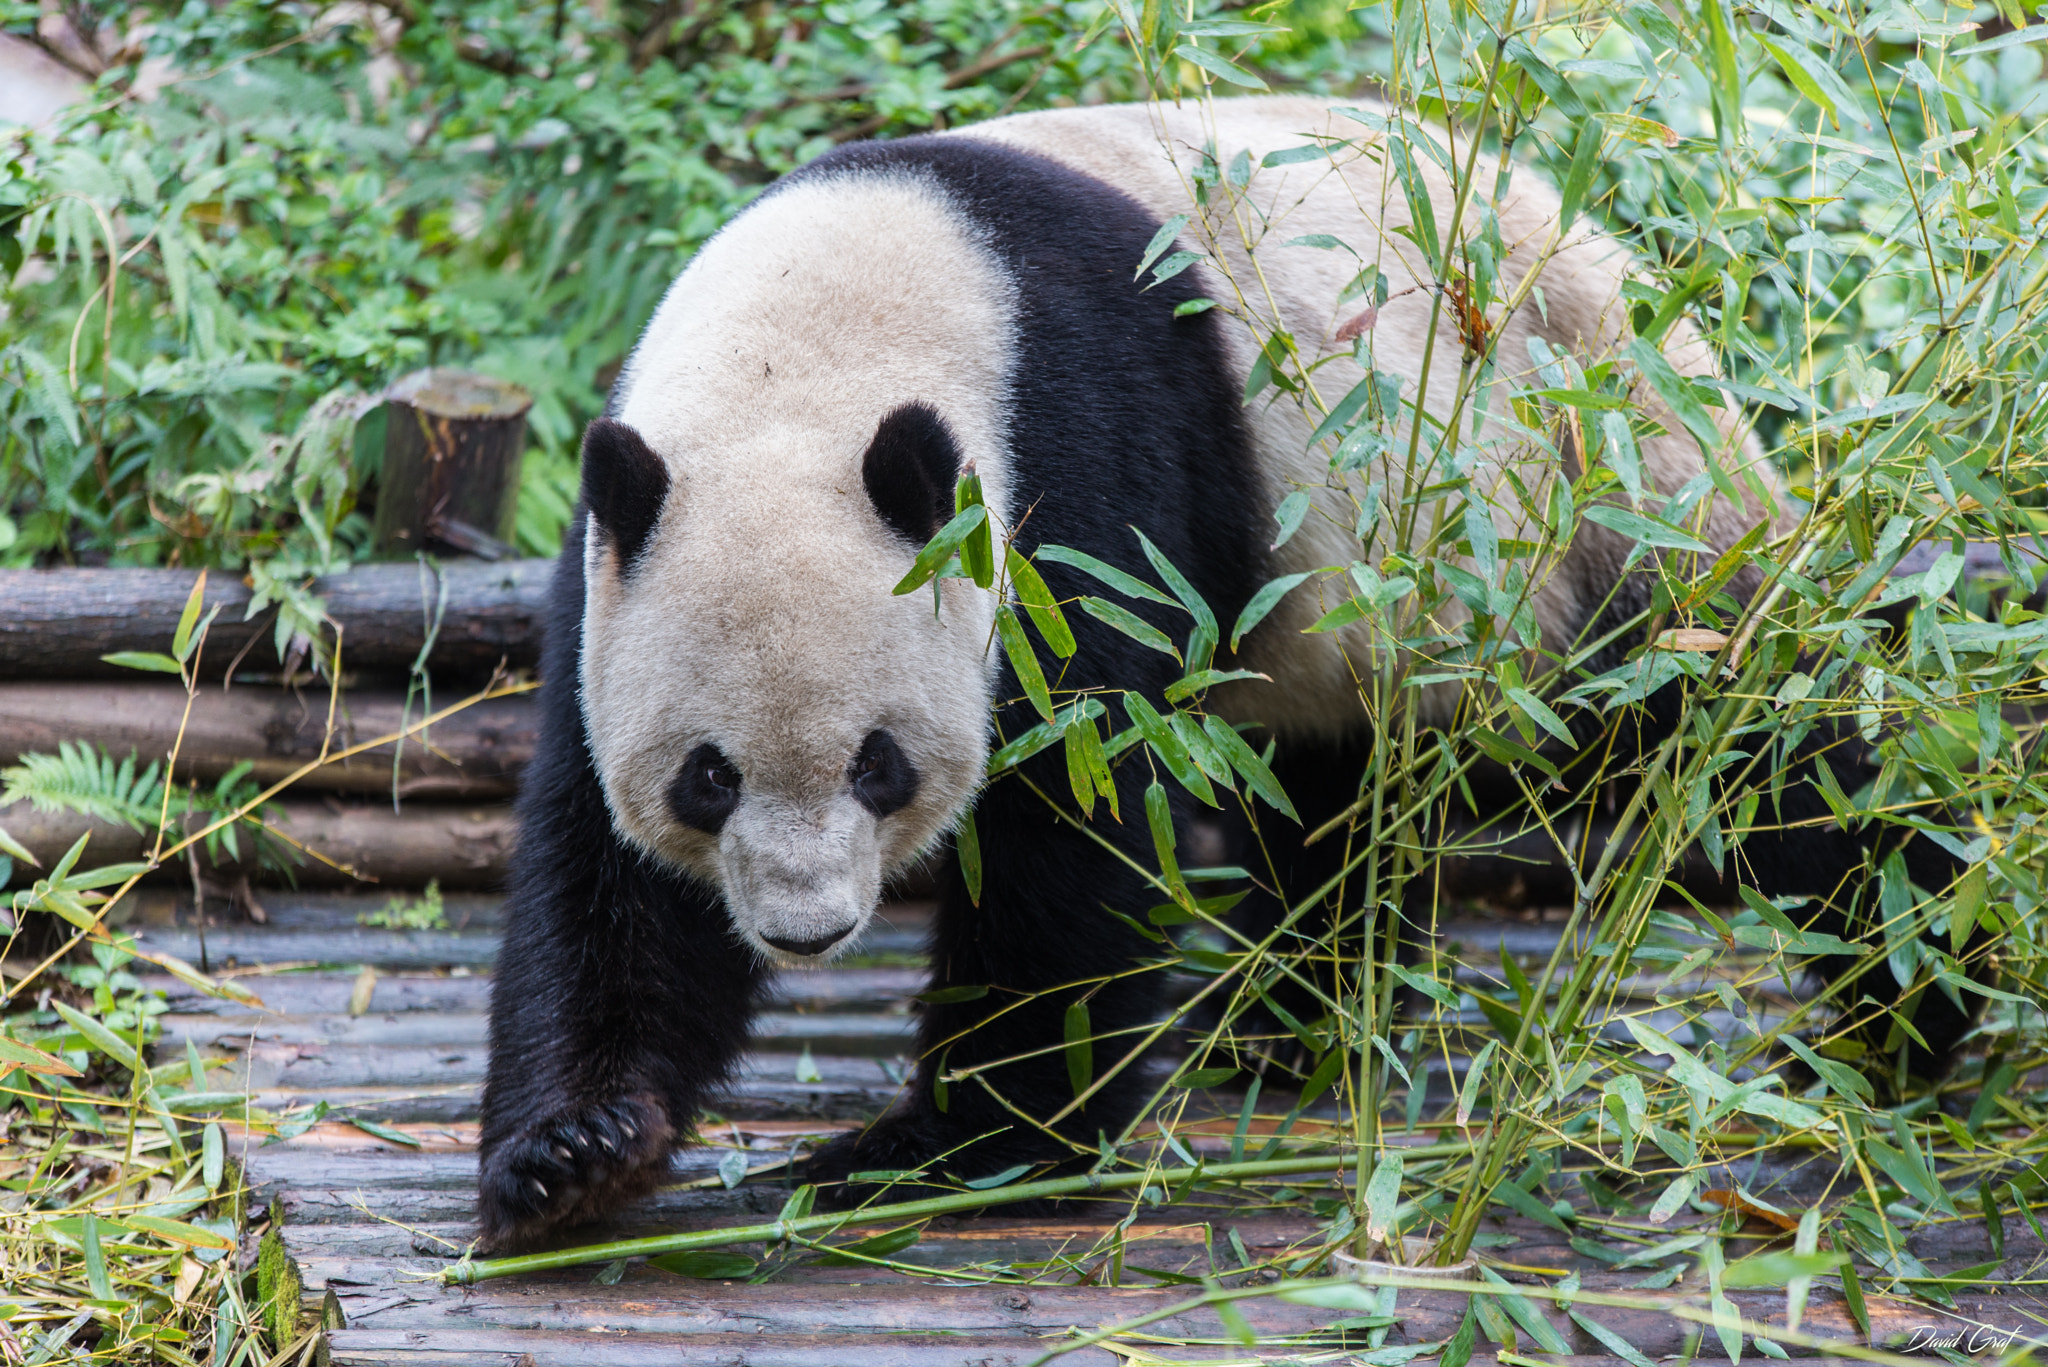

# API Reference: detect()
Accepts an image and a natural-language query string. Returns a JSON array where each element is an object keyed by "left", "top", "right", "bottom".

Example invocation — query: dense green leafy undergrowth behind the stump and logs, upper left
[{"left": 0, "top": 0, "right": 1139, "bottom": 652}]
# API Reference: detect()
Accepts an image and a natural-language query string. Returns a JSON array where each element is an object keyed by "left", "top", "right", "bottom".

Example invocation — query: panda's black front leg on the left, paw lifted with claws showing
[{"left": 479, "top": 516, "right": 762, "bottom": 1248}]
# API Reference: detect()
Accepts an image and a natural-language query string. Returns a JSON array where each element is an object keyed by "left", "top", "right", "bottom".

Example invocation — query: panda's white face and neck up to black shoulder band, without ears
[{"left": 580, "top": 168, "right": 1012, "bottom": 963}]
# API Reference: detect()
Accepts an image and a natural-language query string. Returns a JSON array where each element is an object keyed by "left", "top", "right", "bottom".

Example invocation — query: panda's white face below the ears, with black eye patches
[{"left": 582, "top": 471, "right": 989, "bottom": 961}]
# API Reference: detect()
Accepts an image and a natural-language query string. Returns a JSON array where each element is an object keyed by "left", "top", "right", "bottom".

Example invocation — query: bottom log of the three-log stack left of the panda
[{"left": 0, "top": 801, "right": 514, "bottom": 889}]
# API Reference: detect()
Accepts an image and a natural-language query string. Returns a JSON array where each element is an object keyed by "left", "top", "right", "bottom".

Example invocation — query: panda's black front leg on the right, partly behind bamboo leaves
[{"left": 807, "top": 770, "right": 1163, "bottom": 1201}]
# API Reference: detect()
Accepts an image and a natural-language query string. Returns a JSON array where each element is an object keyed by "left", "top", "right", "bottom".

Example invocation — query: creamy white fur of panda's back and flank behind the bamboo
[{"left": 961, "top": 96, "right": 1778, "bottom": 736}]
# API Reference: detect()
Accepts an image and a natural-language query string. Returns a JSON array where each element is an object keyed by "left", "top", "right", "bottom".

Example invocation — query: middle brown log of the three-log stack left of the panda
[{"left": 0, "top": 682, "right": 539, "bottom": 801}]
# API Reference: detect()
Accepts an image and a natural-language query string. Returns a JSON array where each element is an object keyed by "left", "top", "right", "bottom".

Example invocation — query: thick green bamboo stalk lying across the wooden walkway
[{"left": 440, "top": 1144, "right": 1470, "bottom": 1287}]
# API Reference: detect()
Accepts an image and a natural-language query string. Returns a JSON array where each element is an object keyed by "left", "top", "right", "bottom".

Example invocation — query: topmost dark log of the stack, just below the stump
[{"left": 0, "top": 560, "right": 555, "bottom": 682}]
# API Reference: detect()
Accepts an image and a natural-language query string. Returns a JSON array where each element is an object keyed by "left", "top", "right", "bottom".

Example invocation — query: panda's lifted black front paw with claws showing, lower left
[{"left": 477, "top": 1094, "right": 676, "bottom": 1250}]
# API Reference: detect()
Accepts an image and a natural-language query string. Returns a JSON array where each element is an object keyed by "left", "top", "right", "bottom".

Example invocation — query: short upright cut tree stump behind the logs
[{"left": 375, "top": 369, "right": 532, "bottom": 560}]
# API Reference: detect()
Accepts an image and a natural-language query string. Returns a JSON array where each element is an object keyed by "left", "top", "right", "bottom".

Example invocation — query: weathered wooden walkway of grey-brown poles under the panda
[{"left": 129, "top": 896, "right": 2048, "bottom": 1367}]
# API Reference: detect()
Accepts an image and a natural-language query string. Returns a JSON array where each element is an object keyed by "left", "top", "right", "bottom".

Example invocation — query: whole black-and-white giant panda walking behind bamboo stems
[{"left": 481, "top": 98, "right": 1966, "bottom": 1246}]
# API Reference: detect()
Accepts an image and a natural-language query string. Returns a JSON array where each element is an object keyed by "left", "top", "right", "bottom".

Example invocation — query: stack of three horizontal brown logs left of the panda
[{"left": 0, "top": 560, "right": 553, "bottom": 892}]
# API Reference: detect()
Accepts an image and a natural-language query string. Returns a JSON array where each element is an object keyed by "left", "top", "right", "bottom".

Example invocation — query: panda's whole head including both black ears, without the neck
[{"left": 580, "top": 396, "right": 993, "bottom": 963}]
